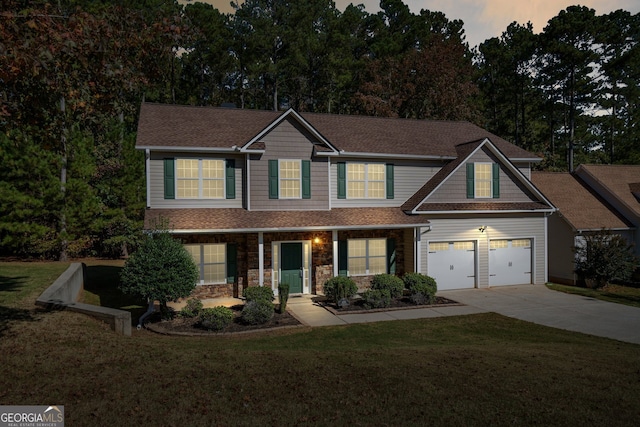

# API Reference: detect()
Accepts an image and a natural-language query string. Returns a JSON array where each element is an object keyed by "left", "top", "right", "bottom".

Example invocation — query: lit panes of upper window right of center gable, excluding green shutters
[{"left": 347, "top": 163, "right": 386, "bottom": 199}]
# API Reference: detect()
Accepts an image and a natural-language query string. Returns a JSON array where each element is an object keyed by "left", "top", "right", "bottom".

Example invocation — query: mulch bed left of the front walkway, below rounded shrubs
[{"left": 145, "top": 304, "right": 302, "bottom": 335}]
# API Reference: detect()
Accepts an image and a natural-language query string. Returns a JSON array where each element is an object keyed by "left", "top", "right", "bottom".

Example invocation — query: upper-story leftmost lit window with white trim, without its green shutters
[{"left": 176, "top": 159, "right": 225, "bottom": 199}]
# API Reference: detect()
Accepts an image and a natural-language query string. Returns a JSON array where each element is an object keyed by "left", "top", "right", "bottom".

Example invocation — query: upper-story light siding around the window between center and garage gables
[{"left": 331, "top": 158, "right": 442, "bottom": 208}]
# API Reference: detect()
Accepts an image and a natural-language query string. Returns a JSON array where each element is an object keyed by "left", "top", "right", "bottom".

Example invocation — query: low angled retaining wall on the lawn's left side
[{"left": 36, "top": 262, "right": 131, "bottom": 336}]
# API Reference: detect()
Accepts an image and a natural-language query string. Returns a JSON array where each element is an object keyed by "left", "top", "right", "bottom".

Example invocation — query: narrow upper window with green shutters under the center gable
[{"left": 269, "top": 159, "right": 311, "bottom": 199}]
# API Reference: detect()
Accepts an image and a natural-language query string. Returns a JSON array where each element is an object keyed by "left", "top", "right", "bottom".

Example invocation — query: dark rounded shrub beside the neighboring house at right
[{"left": 573, "top": 230, "right": 638, "bottom": 289}]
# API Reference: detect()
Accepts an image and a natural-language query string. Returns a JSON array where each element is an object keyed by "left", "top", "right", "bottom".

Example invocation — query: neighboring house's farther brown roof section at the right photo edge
[{"left": 576, "top": 165, "right": 640, "bottom": 221}]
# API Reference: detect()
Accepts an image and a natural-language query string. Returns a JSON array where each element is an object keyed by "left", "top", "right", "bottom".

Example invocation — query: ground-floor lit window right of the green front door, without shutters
[{"left": 347, "top": 238, "right": 387, "bottom": 276}]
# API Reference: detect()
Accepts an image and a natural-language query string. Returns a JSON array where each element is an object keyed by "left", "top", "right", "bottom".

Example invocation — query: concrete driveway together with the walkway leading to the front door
[{"left": 288, "top": 285, "right": 640, "bottom": 344}]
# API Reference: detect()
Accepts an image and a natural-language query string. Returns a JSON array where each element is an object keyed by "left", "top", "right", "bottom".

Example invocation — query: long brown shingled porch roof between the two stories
[{"left": 145, "top": 208, "right": 429, "bottom": 233}]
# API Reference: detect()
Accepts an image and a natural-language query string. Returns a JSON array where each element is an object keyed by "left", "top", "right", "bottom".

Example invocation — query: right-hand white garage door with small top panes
[{"left": 489, "top": 239, "right": 531, "bottom": 286}]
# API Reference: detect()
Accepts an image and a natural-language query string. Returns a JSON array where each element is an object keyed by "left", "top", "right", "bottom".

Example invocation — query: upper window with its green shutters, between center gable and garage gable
[{"left": 337, "top": 162, "right": 394, "bottom": 199}]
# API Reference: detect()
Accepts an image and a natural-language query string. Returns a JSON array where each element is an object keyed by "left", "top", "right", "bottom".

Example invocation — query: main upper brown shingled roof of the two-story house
[{"left": 136, "top": 103, "right": 540, "bottom": 162}]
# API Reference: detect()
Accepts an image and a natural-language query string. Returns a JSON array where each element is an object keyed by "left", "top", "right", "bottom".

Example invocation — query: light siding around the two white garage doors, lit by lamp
[{"left": 420, "top": 216, "right": 547, "bottom": 287}]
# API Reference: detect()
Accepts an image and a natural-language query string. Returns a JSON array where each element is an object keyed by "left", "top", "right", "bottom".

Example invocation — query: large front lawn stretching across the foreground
[{"left": 0, "top": 264, "right": 640, "bottom": 426}]
